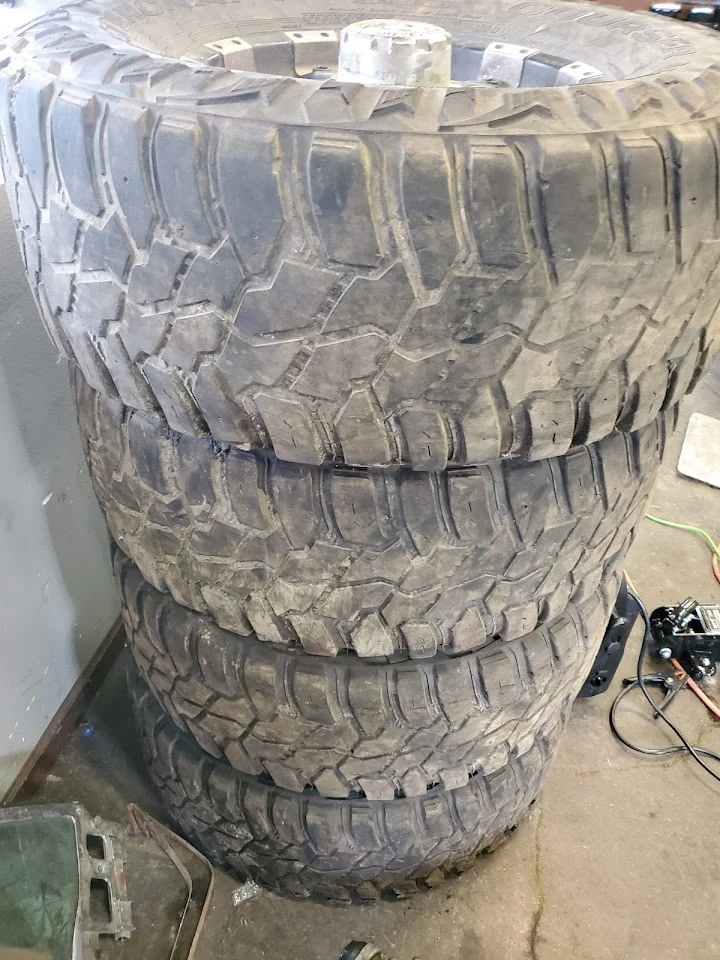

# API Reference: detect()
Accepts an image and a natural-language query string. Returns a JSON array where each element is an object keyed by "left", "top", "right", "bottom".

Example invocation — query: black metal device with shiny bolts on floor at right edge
[{"left": 650, "top": 597, "right": 720, "bottom": 680}]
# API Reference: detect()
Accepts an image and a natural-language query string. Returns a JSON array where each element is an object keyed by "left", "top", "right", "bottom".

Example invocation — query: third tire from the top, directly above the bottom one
[{"left": 115, "top": 551, "right": 619, "bottom": 800}]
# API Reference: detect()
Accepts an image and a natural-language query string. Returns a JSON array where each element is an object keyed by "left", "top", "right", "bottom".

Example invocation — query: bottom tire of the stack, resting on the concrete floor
[{"left": 130, "top": 671, "right": 570, "bottom": 901}]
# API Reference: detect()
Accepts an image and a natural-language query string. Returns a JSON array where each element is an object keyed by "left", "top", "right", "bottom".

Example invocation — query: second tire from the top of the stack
[{"left": 74, "top": 364, "right": 676, "bottom": 659}]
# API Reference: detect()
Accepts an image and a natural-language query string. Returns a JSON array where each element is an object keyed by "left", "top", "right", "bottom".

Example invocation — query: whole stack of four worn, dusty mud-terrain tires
[{"left": 0, "top": 0, "right": 720, "bottom": 900}]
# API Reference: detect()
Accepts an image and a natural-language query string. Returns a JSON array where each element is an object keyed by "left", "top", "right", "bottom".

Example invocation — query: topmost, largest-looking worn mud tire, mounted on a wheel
[{"left": 0, "top": 0, "right": 720, "bottom": 470}]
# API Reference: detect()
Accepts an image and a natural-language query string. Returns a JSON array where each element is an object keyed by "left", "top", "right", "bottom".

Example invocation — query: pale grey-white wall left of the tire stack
[{"left": 0, "top": 189, "right": 119, "bottom": 798}]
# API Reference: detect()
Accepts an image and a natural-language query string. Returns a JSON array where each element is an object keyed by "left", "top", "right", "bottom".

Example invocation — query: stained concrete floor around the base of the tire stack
[{"left": 31, "top": 368, "right": 720, "bottom": 960}]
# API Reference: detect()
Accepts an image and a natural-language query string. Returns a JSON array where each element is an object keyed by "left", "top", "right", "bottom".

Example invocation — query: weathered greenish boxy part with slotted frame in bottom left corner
[{"left": 0, "top": 803, "right": 219, "bottom": 960}]
